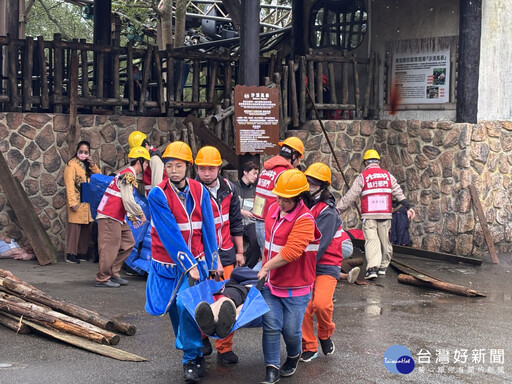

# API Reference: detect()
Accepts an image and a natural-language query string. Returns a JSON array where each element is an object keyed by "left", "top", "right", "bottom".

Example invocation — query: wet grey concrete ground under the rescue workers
[{"left": 0, "top": 252, "right": 512, "bottom": 384}]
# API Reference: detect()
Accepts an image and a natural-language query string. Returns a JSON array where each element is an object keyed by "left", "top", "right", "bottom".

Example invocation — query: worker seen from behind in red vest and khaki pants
[{"left": 337, "top": 149, "right": 416, "bottom": 280}]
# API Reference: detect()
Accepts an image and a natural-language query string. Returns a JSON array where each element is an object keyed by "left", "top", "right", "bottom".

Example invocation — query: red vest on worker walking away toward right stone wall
[{"left": 361, "top": 167, "right": 392, "bottom": 214}]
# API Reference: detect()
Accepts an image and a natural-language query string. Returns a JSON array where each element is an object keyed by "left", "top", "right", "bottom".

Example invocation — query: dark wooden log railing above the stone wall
[{"left": 0, "top": 34, "right": 379, "bottom": 132}]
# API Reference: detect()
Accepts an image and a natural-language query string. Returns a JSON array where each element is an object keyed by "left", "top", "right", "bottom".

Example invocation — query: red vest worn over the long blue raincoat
[{"left": 151, "top": 179, "right": 204, "bottom": 264}]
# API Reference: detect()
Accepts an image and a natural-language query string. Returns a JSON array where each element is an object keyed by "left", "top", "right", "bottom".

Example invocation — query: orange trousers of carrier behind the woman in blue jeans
[{"left": 302, "top": 275, "right": 338, "bottom": 352}]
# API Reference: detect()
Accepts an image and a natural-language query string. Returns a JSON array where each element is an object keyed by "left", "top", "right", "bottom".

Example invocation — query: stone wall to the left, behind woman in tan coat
[{"left": 0, "top": 113, "right": 182, "bottom": 251}]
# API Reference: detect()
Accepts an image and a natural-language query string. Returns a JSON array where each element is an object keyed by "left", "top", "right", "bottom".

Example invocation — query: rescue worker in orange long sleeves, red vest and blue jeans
[{"left": 258, "top": 169, "right": 320, "bottom": 384}]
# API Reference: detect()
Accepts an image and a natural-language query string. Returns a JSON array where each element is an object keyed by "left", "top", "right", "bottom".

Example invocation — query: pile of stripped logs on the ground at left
[{"left": 0, "top": 269, "right": 146, "bottom": 361}]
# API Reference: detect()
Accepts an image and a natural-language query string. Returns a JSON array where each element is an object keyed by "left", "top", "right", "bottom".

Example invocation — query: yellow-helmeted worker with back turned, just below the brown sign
[{"left": 252, "top": 137, "right": 304, "bottom": 252}]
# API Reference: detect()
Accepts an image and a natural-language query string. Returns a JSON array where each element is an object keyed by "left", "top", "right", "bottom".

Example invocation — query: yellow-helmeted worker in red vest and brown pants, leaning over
[{"left": 96, "top": 147, "right": 150, "bottom": 288}]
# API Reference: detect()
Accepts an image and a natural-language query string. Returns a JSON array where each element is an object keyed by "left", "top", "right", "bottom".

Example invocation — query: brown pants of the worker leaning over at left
[{"left": 96, "top": 219, "right": 135, "bottom": 283}]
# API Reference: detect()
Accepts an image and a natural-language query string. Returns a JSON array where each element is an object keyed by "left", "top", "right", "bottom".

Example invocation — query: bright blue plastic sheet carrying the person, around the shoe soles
[{"left": 178, "top": 280, "right": 270, "bottom": 339}]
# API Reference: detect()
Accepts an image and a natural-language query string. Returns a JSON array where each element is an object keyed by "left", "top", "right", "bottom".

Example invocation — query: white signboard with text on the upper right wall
[{"left": 392, "top": 50, "right": 450, "bottom": 104}]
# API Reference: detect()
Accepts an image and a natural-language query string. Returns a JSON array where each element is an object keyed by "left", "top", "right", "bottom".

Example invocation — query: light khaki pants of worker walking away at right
[{"left": 363, "top": 219, "right": 393, "bottom": 270}]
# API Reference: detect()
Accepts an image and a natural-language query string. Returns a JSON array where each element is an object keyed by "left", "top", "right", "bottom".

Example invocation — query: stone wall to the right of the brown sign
[{"left": 298, "top": 120, "right": 512, "bottom": 257}]
